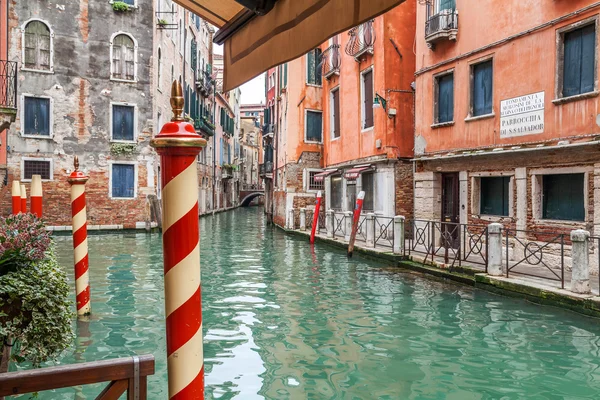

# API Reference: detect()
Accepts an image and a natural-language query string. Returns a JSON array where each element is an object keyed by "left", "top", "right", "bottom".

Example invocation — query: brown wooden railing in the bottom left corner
[{"left": 0, "top": 355, "right": 154, "bottom": 400}]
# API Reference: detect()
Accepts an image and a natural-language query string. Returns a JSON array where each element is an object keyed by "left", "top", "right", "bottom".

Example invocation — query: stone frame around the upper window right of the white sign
[{"left": 553, "top": 15, "right": 600, "bottom": 104}]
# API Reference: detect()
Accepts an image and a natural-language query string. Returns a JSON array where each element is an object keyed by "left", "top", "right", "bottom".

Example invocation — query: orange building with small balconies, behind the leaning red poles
[{"left": 267, "top": 2, "right": 416, "bottom": 225}]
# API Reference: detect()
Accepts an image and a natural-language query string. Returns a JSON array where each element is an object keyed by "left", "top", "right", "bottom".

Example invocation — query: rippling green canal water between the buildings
[{"left": 21, "top": 208, "right": 600, "bottom": 400}]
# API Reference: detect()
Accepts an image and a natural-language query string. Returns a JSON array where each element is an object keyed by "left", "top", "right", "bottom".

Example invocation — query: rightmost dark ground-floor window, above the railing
[{"left": 542, "top": 174, "right": 585, "bottom": 221}]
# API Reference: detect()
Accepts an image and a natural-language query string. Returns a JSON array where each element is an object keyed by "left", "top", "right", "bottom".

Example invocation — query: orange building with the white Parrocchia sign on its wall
[{"left": 415, "top": 0, "right": 600, "bottom": 238}]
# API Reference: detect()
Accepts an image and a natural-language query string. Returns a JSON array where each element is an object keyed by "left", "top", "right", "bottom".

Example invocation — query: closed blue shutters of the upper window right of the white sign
[{"left": 562, "top": 24, "right": 596, "bottom": 97}]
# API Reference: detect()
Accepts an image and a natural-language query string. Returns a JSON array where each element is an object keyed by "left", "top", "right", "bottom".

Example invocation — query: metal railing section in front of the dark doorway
[{"left": 404, "top": 220, "right": 488, "bottom": 272}]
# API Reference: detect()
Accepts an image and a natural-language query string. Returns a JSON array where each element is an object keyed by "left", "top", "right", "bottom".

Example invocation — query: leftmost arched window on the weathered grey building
[{"left": 23, "top": 20, "right": 52, "bottom": 71}]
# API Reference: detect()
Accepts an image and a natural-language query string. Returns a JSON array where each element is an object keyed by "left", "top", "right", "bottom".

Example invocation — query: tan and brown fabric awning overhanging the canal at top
[{"left": 175, "top": 0, "right": 405, "bottom": 91}]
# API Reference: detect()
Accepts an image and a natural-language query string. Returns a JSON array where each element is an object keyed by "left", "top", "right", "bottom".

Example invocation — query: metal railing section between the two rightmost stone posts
[{"left": 503, "top": 229, "right": 570, "bottom": 289}]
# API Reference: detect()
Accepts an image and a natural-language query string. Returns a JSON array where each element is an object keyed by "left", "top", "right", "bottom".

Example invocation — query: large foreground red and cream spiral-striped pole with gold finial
[{"left": 150, "top": 82, "right": 206, "bottom": 400}]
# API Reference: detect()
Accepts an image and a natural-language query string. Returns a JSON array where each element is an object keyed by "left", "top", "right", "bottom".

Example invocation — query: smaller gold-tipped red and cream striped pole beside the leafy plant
[{"left": 67, "top": 156, "right": 92, "bottom": 316}]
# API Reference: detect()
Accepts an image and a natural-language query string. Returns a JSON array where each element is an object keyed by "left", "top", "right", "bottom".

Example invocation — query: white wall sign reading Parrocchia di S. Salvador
[{"left": 500, "top": 92, "right": 545, "bottom": 139}]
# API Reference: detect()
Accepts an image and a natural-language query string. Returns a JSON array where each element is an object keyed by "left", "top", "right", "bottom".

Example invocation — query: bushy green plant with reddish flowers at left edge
[{"left": 0, "top": 214, "right": 73, "bottom": 373}]
